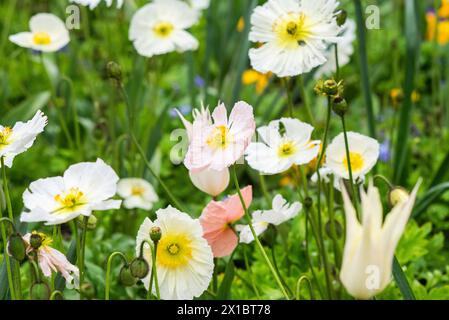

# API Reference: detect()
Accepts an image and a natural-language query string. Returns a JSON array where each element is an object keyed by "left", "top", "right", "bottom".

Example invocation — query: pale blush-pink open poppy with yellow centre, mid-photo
[{"left": 184, "top": 101, "right": 256, "bottom": 172}]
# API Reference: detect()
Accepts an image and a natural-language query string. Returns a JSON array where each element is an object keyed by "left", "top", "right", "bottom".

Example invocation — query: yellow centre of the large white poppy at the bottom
[{"left": 156, "top": 234, "right": 192, "bottom": 268}]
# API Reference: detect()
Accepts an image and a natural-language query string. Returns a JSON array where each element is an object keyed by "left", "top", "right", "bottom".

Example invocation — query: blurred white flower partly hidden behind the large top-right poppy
[{"left": 314, "top": 19, "right": 356, "bottom": 79}]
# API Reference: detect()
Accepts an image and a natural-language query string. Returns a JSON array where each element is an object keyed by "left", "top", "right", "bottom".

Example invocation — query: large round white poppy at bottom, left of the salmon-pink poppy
[{"left": 136, "top": 206, "right": 214, "bottom": 300}]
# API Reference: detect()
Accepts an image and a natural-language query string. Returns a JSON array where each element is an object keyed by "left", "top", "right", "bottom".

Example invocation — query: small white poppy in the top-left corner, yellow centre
[{"left": 9, "top": 13, "right": 70, "bottom": 52}]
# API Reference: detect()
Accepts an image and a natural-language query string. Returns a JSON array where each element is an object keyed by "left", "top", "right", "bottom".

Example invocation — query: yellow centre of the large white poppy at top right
[{"left": 274, "top": 14, "right": 310, "bottom": 47}]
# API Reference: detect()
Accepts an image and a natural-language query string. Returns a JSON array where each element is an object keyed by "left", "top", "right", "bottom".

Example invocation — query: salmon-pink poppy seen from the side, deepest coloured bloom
[{"left": 200, "top": 186, "right": 253, "bottom": 257}]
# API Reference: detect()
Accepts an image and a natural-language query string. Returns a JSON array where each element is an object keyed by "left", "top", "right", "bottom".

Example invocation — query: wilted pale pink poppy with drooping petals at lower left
[{"left": 23, "top": 232, "right": 79, "bottom": 289}]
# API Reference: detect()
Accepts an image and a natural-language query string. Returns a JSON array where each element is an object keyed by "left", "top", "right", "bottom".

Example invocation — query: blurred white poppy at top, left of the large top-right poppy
[{"left": 129, "top": 0, "right": 199, "bottom": 57}]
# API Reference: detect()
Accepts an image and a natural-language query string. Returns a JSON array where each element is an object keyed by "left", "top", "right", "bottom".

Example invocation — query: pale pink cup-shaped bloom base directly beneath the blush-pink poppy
[{"left": 189, "top": 168, "right": 229, "bottom": 197}]
